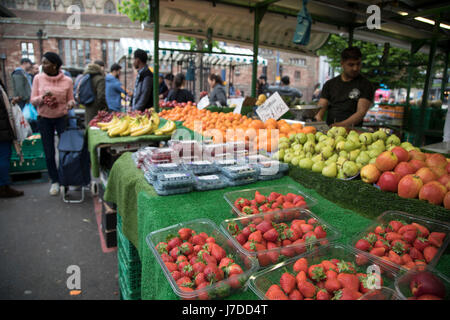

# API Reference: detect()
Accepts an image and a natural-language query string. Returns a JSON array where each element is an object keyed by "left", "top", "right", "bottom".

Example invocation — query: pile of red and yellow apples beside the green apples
[{"left": 361, "top": 147, "right": 450, "bottom": 209}]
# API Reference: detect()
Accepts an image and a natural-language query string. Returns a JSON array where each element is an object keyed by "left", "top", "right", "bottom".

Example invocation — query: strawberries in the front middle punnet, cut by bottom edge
[{"left": 265, "top": 258, "right": 383, "bottom": 300}]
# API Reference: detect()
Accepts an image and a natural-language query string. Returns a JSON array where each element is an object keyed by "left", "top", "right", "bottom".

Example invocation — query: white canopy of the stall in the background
[{"left": 120, "top": 38, "right": 267, "bottom": 66}]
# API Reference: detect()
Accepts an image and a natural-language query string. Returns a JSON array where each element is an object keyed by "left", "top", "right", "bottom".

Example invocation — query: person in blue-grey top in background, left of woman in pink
[{"left": 11, "top": 58, "right": 33, "bottom": 109}]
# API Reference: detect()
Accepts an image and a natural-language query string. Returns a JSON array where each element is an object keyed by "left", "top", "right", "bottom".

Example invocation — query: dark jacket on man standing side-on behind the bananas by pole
[{"left": 133, "top": 65, "right": 153, "bottom": 111}]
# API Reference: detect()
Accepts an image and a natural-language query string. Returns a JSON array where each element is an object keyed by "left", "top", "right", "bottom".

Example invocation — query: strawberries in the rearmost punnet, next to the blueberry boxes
[{"left": 234, "top": 191, "right": 308, "bottom": 215}]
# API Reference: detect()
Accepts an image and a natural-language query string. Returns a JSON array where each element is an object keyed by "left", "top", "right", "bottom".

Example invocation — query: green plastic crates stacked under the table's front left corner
[{"left": 117, "top": 214, "right": 141, "bottom": 300}]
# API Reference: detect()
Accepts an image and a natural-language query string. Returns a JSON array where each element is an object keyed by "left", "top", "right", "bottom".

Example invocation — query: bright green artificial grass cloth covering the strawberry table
[{"left": 105, "top": 153, "right": 450, "bottom": 300}]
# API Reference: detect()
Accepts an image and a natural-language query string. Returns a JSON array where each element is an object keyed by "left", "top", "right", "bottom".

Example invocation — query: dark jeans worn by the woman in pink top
[{"left": 38, "top": 116, "right": 66, "bottom": 183}]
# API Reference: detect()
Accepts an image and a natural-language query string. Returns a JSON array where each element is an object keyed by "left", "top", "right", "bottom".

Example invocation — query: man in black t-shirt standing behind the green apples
[{"left": 316, "top": 47, "right": 375, "bottom": 127}]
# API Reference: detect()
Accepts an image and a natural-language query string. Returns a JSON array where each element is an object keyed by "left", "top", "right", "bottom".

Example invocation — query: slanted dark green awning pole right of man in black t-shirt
[{"left": 414, "top": 15, "right": 441, "bottom": 147}]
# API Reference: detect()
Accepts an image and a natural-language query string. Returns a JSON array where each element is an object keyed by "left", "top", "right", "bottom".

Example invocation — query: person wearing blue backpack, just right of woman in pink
[{"left": 83, "top": 61, "right": 108, "bottom": 128}]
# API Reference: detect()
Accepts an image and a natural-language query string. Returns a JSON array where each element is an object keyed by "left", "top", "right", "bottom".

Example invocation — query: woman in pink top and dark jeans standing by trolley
[{"left": 31, "top": 52, "right": 75, "bottom": 195}]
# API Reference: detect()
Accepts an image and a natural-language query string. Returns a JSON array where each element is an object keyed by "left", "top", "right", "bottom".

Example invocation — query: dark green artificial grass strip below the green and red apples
[{"left": 289, "top": 165, "right": 450, "bottom": 222}]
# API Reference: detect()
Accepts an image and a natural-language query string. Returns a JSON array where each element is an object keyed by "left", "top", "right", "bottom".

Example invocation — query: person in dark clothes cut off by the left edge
[{"left": 0, "top": 80, "right": 24, "bottom": 198}]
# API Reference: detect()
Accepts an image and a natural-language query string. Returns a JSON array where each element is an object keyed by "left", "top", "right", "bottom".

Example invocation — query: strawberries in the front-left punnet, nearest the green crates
[{"left": 156, "top": 228, "right": 247, "bottom": 300}]
